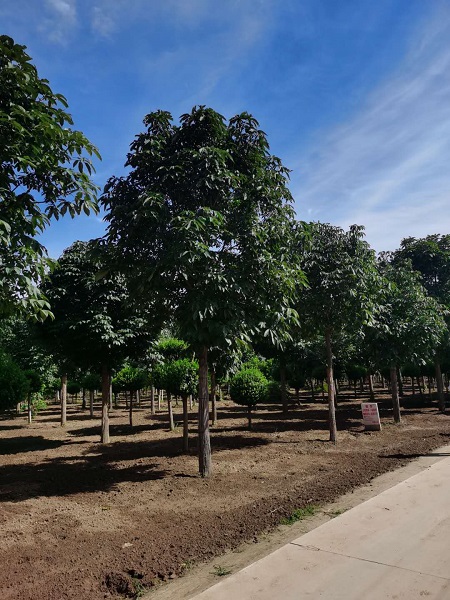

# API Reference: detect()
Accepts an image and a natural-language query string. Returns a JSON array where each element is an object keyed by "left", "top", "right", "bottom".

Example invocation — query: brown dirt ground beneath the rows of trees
[{"left": 0, "top": 386, "right": 450, "bottom": 600}]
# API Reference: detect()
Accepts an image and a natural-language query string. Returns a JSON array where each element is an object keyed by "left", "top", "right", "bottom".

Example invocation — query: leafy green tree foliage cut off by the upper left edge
[{"left": 0, "top": 35, "right": 100, "bottom": 319}]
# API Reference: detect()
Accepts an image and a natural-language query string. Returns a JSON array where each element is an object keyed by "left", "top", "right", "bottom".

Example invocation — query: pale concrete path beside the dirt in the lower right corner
[{"left": 193, "top": 448, "right": 450, "bottom": 600}]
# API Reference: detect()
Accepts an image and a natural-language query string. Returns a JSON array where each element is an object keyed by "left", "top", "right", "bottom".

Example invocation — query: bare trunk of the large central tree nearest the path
[{"left": 198, "top": 346, "right": 211, "bottom": 477}]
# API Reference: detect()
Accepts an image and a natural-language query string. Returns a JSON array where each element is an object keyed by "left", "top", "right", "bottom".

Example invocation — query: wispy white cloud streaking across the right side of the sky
[{"left": 294, "top": 4, "right": 450, "bottom": 250}]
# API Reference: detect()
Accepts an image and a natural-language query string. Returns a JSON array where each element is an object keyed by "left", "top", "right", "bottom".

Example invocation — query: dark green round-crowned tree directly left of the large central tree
[{"left": 42, "top": 242, "right": 150, "bottom": 443}]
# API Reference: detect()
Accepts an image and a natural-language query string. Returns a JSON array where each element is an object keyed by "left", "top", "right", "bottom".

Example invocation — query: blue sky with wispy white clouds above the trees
[{"left": 0, "top": 0, "right": 450, "bottom": 257}]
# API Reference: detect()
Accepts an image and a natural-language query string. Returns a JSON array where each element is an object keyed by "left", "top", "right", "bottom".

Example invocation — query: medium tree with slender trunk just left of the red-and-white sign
[{"left": 298, "top": 223, "right": 378, "bottom": 443}]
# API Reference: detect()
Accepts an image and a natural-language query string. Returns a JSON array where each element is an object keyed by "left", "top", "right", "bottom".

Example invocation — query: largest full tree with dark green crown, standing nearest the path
[{"left": 102, "top": 106, "right": 298, "bottom": 477}]
